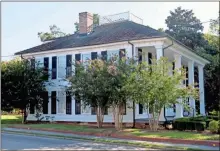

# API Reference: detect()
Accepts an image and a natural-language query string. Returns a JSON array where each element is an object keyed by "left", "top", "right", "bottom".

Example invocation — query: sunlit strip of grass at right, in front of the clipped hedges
[{"left": 123, "top": 129, "right": 219, "bottom": 140}]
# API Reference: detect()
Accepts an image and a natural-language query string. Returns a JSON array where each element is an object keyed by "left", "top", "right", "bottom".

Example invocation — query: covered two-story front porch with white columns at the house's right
[{"left": 131, "top": 37, "right": 207, "bottom": 122}]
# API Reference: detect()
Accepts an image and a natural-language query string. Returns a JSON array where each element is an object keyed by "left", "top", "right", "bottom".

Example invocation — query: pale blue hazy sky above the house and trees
[{"left": 1, "top": 2, "right": 219, "bottom": 60}]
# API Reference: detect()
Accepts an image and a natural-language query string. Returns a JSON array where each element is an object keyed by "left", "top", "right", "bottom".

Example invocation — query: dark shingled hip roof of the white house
[{"left": 15, "top": 21, "right": 167, "bottom": 55}]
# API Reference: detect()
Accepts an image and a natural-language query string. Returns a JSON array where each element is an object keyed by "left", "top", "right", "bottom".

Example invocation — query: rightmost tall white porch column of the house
[{"left": 198, "top": 65, "right": 205, "bottom": 115}]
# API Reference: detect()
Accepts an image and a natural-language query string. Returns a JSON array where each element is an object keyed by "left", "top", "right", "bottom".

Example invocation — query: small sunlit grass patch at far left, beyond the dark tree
[{"left": 1, "top": 115, "right": 22, "bottom": 124}]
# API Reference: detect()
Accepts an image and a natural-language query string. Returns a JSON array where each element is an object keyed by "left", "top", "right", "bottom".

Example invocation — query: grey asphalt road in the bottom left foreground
[{"left": 1, "top": 133, "right": 149, "bottom": 150}]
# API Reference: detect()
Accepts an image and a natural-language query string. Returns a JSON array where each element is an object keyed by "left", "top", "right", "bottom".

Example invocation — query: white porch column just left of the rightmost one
[{"left": 188, "top": 60, "right": 196, "bottom": 116}]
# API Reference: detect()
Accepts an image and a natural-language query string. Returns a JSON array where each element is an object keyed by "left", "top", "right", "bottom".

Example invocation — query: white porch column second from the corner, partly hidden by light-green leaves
[{"left": 174, "top": 53, "right": 183, "bottom": 118}]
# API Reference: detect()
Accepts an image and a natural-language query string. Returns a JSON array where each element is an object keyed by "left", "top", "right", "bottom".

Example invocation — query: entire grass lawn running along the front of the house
[{"left": 1, "top": 115, "right": 219, "bottom": 140}]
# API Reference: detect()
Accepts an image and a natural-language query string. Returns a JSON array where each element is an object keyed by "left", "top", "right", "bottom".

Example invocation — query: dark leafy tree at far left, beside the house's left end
[{"left": 1, "top": 58, "right": 48, "bottom": 122}]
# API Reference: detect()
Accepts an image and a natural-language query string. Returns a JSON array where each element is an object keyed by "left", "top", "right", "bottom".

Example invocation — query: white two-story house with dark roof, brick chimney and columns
[{"left": 15, "top": 12, "right": 209, "bottom": 123}]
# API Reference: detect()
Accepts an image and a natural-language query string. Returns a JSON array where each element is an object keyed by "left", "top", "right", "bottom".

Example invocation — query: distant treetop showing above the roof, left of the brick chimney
[{"left": 38, "top": 25, "right": 70, "bottom": 42}]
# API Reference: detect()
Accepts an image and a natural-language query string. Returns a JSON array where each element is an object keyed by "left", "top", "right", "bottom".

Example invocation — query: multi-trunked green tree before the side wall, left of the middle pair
[{"left": 69, "top": 59, "right": 110, "bottom": 128}]
